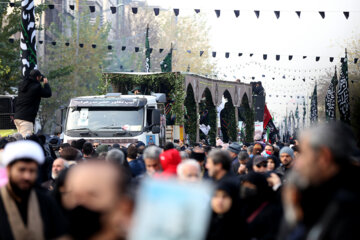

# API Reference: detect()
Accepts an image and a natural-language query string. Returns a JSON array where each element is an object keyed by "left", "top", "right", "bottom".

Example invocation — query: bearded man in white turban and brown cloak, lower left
[{"left": 0, "top": 140, "right": 66, "bottom": 240}]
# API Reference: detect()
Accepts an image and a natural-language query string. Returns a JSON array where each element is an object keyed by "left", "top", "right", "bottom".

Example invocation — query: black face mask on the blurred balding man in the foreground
[{"left": 69, "top": 206, "right": 101, "bottom": 239}]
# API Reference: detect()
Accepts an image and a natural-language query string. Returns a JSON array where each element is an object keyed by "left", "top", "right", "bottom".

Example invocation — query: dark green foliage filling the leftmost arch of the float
[{"left": 184, "top": 85, "right": 196, "bottom": 144}]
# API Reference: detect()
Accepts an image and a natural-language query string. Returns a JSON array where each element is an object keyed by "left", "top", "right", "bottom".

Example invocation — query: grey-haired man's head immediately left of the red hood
[{"left": 143, "top": 146, "right": 162, "bottom": 177}]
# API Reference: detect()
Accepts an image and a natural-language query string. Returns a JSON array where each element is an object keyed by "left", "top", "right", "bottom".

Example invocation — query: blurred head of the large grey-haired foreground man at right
[{"left": 294, "top": 122, "right": 358, "bottom": 186}]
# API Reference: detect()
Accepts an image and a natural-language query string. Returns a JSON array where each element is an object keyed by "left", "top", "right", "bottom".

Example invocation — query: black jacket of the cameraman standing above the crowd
[{"left": 15, "top": 79, "right": 51, "bottom": 123}]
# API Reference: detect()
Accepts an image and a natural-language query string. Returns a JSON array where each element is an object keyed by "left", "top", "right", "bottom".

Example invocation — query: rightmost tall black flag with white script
[{"left": 337, "top": 50, "right": 350, "bottom": 124}]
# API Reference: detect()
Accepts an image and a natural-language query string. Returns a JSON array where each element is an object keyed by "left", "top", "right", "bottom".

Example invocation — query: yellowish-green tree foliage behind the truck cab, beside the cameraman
[{"left": 39, "top": 14, "right": 110, "bottom": 131}]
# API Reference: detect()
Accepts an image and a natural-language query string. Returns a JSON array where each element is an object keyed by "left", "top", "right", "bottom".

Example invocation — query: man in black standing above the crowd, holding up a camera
[{"left": 14, "top": 69, "right": 51, "bottom": 137}]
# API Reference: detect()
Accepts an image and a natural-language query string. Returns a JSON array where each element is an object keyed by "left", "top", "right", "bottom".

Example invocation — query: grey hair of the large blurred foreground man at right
[{"left": 302, "top": 122, "right": 358, "bottom": 165}]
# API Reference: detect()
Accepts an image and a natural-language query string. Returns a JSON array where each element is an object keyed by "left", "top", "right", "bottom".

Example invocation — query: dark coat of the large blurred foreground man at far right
[{"left": 279, "top": 167, "right": 360, "bottom": 240}]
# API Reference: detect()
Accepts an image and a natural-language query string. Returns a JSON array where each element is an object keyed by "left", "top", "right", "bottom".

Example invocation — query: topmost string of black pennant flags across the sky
[{"left": 0, "top": 2, "right": 359, "bottom": 19}]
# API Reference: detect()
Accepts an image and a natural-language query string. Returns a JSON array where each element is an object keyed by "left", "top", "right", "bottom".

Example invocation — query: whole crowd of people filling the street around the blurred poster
[{"left": 0, "top": 123, "right": 360, "bottom": 240}]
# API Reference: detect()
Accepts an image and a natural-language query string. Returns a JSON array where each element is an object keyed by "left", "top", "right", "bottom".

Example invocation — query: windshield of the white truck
[{"left": 66, "top": 107, "right": 144, "bottom": 132}]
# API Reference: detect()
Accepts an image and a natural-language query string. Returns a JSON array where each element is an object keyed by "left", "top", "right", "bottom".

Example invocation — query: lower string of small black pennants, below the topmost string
[{"left": 9, "top": 38, "right": 359, "bottom": 64}]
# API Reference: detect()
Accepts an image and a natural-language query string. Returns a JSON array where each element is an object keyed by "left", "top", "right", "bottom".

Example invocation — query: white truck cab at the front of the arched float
[{"left": 63, "top": 93, "right": 166, "bottom": 146}]
